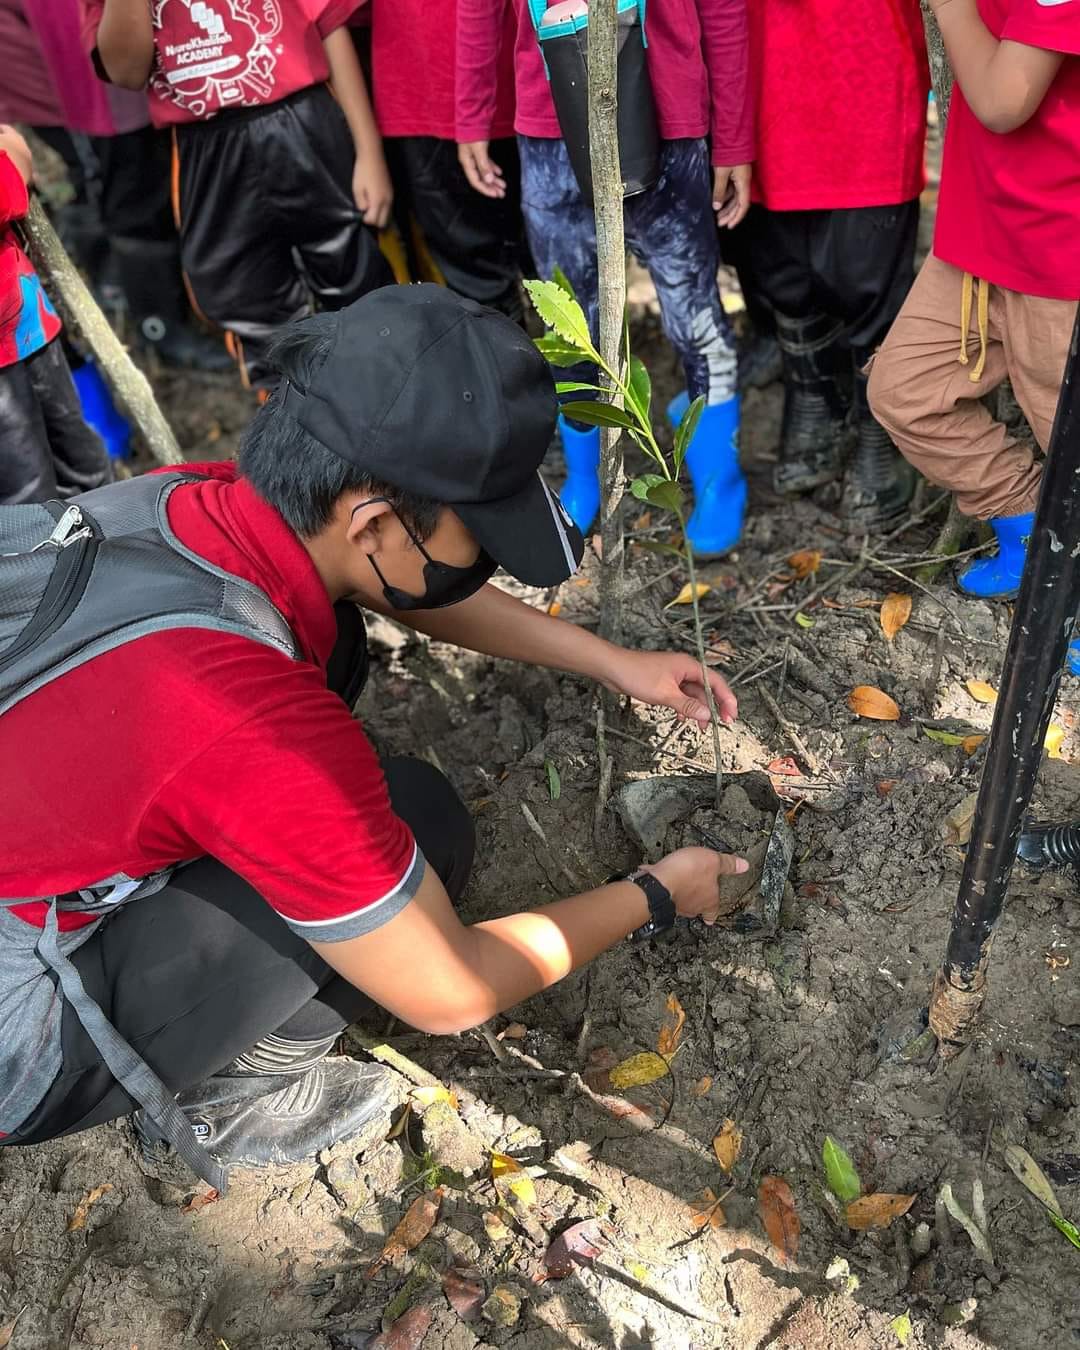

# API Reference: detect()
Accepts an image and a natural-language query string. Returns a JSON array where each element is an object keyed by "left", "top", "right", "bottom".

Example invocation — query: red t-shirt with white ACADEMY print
[{"left": 81, "top": 0, "right": 356, "bottom": 127}]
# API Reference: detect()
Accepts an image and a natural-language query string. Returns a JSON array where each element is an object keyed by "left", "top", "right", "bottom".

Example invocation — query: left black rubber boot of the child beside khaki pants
[{"left": 772, "top": 313, "right": 849, "bottom": 493}]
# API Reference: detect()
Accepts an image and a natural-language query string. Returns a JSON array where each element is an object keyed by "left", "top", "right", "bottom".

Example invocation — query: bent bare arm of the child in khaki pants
[{"left": 930, "top": 0, "right": 1065, "bottom": 134}]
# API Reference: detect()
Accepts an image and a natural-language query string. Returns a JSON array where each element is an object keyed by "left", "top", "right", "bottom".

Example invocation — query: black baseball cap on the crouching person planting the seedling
[{"left": 284, "top": 285, "right": 585, "bottom": 586}]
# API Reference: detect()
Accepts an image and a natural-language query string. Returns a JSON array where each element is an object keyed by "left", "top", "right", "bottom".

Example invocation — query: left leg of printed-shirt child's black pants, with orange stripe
[{"left": 173, "top": 116, "right": 309, "bottom": 387}]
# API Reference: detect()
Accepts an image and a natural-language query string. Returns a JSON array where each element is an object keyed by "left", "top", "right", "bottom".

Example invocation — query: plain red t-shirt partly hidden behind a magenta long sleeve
[{"left": 367, "top": 0, "right": 516, "bottom": 140}]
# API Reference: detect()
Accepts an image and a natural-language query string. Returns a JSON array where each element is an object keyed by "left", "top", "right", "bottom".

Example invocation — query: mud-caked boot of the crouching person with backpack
[{"left": 134, "top": 1035, "right": 394, "bottom": 1168}]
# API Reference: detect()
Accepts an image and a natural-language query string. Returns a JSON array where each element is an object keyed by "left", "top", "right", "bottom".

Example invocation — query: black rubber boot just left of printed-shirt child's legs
[{"left": 112, "top": 236, "right": 235, "bottom": 373}]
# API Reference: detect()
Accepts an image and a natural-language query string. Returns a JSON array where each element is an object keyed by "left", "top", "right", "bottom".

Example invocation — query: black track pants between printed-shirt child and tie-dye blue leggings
[{"left": 383, "top": 136, "right": 525, "bottom": 321}]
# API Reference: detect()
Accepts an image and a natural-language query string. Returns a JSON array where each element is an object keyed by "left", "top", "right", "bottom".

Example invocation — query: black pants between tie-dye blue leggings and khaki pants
[{"left": 737, "top": 198, "right": 919, "bottom": 359}]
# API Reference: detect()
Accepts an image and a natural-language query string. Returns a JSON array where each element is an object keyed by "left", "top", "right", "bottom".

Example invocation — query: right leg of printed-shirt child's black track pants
[{"left": 278, "top": 85, "right": 394, "bottom": 309}]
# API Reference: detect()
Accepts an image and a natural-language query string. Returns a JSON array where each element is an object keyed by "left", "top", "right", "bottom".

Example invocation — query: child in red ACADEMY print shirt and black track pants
[{"left": 82, "top": 0, "right": 393, "bottom": 387}]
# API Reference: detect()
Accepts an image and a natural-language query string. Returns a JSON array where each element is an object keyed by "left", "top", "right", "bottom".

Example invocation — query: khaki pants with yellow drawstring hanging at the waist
[{"left": 869, "top": 255, "right": 1076, "bottom": 520}]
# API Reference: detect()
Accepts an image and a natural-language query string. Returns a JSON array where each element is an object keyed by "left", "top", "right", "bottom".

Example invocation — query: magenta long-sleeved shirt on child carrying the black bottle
[{"left": 456, "top": 0, "right": 753, "bottom": 165}]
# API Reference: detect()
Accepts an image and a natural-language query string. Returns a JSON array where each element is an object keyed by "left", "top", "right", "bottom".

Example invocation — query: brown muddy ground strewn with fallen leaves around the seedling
[{"left": 10, "top": 137, "right": 1080, "bottom": 1350}]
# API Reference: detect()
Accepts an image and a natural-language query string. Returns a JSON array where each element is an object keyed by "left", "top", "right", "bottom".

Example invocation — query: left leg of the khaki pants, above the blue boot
[{"left": 869, "top": 255, "right": 1036, "bottom": 520}]
